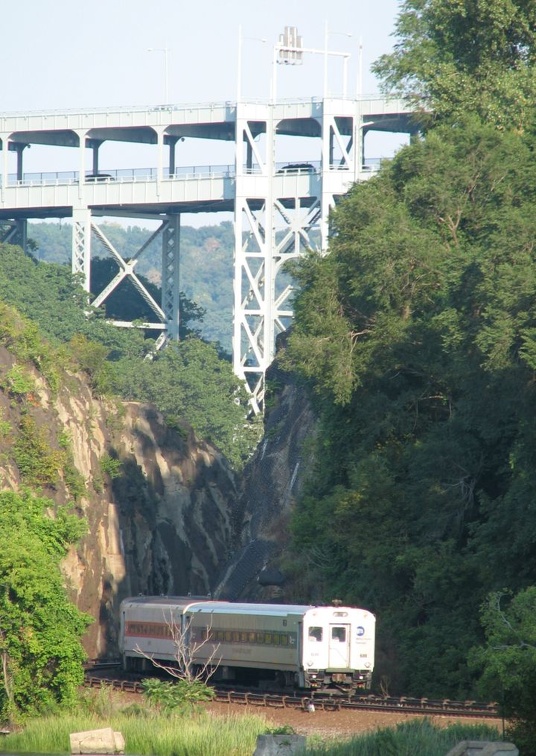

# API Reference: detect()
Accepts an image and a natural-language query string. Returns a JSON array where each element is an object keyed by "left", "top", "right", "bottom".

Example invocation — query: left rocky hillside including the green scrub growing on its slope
[{"left": 0, "top": 303, "right": 236, "bottom": 658}]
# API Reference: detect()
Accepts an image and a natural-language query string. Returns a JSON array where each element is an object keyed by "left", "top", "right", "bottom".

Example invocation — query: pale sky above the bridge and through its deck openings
[{"left": 0, "top": 0, "right": 401, "bottom": 225}]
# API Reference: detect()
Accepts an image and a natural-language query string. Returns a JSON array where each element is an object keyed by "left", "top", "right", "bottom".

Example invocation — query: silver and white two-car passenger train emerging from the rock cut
[{"left": 119, "top": 596, "right": 376, "bottom": 695}]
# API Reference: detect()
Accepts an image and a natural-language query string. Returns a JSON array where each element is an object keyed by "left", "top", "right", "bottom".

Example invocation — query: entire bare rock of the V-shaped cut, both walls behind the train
[{"left": 0, "top": 322, "right": 315, "bottom": 658}]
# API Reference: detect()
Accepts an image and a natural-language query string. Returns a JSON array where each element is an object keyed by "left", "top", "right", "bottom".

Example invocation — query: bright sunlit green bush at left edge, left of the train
[{"left": 0, "top": 491, "right": 90, "bottom": 717}]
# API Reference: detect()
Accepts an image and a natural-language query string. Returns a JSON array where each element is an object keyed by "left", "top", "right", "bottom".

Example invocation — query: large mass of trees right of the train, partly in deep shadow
[{"left": 285, "top": 120, "right": 536, "bottom": 697}]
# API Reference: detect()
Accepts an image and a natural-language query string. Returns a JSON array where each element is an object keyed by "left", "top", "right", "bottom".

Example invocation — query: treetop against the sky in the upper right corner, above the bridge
[{"left": 373, "top": 0, "right": 536, "bottom": 128}]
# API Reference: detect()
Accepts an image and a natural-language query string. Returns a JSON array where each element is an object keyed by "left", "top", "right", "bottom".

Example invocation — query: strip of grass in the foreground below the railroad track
[{"left": 0, "top": 688, "right": 500, "bottom": 756}]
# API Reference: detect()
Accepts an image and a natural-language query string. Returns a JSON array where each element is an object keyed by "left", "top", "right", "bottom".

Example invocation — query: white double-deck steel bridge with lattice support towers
[{"left": 0, "top": 97, "right": 418, "bottom": 412}]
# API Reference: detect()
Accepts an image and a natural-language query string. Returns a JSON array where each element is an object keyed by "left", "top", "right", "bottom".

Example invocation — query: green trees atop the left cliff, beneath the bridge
[{"left": 0, "top": 245, "right": 261, "bottom": 470}]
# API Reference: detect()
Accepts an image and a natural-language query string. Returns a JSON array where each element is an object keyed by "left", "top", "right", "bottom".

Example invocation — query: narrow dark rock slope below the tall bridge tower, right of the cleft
[{"left": 216, "top": 352, "right": 316, "bottom": 601}]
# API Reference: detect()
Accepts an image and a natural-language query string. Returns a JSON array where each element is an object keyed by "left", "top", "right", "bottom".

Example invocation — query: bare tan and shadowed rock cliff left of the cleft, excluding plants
[{"left": 0, "top": 348, "right": 237, "bottom": 658}]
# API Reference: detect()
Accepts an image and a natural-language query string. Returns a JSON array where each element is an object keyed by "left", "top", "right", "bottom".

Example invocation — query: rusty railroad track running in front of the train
[{"left": 86, "top": 664, "right": 499, "bottom": 719}]
